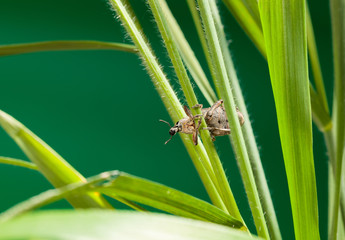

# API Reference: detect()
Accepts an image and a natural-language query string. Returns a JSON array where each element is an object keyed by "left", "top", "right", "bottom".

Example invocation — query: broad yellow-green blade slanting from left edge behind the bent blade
[{"left": 0, "top": 110, "right": 110, "bottom": 208}]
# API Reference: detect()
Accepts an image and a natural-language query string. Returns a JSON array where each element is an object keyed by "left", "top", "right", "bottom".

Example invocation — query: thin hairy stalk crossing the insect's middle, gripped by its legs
[{"left": 149, "top": 0, "right": 242, "bottom": 222}]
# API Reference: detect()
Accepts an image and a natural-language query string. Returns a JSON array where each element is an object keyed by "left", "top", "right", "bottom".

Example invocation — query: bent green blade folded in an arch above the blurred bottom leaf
[{"left": 0, "top": 171, "right": 243, "bottom": 228}]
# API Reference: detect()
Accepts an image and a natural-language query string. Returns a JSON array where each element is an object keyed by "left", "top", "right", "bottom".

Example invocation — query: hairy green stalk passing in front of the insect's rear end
[{"left": 198, "top": 0, "right": 269, "bottom": 239}]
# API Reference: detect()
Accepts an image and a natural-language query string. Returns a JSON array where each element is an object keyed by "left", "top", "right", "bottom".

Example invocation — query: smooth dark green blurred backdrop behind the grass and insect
[{"left": 0, "top": 0, "right": 333, "bottom": 239}]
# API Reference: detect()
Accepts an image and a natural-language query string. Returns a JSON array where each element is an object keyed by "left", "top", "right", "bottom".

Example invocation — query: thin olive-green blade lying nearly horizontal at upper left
[{"left": 0, "top": 40, "right": 137, "bottom": 57}]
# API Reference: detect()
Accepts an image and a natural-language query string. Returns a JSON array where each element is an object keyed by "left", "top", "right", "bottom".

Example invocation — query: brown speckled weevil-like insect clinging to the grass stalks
[{"left": 160, "top": 100, "right": 244, "bottom": 145}]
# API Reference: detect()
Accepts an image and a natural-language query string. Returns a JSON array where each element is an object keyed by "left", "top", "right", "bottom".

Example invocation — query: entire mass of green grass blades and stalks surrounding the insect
[{"left": 0, "top": 0, "right": 345, "bottom": 240}]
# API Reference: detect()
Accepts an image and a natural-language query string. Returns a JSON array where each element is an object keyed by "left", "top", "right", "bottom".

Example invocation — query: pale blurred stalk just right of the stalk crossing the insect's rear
[{"left": 210, "top": 0, "right": 282, "bottom": 240}]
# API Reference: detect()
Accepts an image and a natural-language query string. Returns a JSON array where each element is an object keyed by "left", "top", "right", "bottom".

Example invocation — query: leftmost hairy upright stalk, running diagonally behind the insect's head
[{"left": 110, "top": 0, "right": 223, "bottom": 208}]
